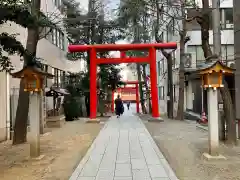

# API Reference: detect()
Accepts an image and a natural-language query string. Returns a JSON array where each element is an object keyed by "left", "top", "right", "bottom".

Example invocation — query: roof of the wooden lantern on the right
[{"left": 185, "top": 60, "right": 235, "bottom": 74}]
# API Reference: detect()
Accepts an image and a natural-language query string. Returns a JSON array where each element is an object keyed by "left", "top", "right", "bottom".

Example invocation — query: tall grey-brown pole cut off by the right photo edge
[{"left": 233, "top": 0, "right": 240, "bottom": 137}]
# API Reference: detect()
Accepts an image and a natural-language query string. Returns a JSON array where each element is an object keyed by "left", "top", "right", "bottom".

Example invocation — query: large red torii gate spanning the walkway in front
[{"left": 68, "top": 42, "right": 177, "bottom": 119}]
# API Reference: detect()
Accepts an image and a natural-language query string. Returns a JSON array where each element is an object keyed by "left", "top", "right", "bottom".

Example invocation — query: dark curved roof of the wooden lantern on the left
[{"left": 11, "top": 66, "right": 54, "bottom": 78}]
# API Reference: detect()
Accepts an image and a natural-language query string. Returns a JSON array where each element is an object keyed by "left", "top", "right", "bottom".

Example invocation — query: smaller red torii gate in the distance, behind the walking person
[{"left": 112, "top": 81, "right": 140, "bottom": 113}]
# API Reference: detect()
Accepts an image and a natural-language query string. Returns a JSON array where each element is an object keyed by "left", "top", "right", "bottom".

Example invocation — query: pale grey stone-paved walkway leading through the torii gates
[{"left": 69, "top": 107, "right": 178, "bottom": 180}]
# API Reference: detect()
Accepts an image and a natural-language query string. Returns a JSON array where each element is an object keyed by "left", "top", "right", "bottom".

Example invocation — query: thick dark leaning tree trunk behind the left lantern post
[{"left": 13, "top": 0, "right": 64, "bottom": 144}]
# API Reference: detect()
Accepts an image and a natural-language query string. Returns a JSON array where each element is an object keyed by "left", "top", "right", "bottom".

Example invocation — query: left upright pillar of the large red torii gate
[{"left": 90, "top": 48, "right": 97, "bottom": 119}]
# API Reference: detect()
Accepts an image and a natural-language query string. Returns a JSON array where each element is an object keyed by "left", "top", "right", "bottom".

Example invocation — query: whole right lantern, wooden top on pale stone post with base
[{"left": 199, "top": 61, "right": 233, "bottom": 159}]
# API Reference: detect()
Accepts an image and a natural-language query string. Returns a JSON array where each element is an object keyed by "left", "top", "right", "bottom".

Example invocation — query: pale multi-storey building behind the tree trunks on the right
[{"left": 157, "top": 0, "right": 234, "bottom": 114}]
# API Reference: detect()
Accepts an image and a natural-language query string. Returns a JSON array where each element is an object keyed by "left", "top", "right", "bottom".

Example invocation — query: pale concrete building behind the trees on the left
[{"left": 0, "top": 0, "right": 85, "bottom": 141}]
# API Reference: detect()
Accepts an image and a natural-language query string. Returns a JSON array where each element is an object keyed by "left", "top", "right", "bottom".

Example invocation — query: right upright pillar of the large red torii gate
[{"left": 149, "top": 47, "right": 160, "bottom": 117}]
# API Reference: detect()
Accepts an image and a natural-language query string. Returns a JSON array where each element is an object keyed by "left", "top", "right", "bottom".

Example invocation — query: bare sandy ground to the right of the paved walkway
[{"left": 140, "top": 115, "right": 240, "bottom": 180}]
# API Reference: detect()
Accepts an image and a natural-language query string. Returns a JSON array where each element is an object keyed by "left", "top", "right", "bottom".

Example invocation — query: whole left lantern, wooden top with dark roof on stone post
[{"left": 11, "top": 66, "right": 53, "bottom": 158}]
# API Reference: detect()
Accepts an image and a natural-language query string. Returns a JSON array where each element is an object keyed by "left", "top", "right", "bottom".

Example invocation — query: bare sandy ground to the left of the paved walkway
[{"left": 0, "top": 120, "right": 103, "bottom": 180}]
